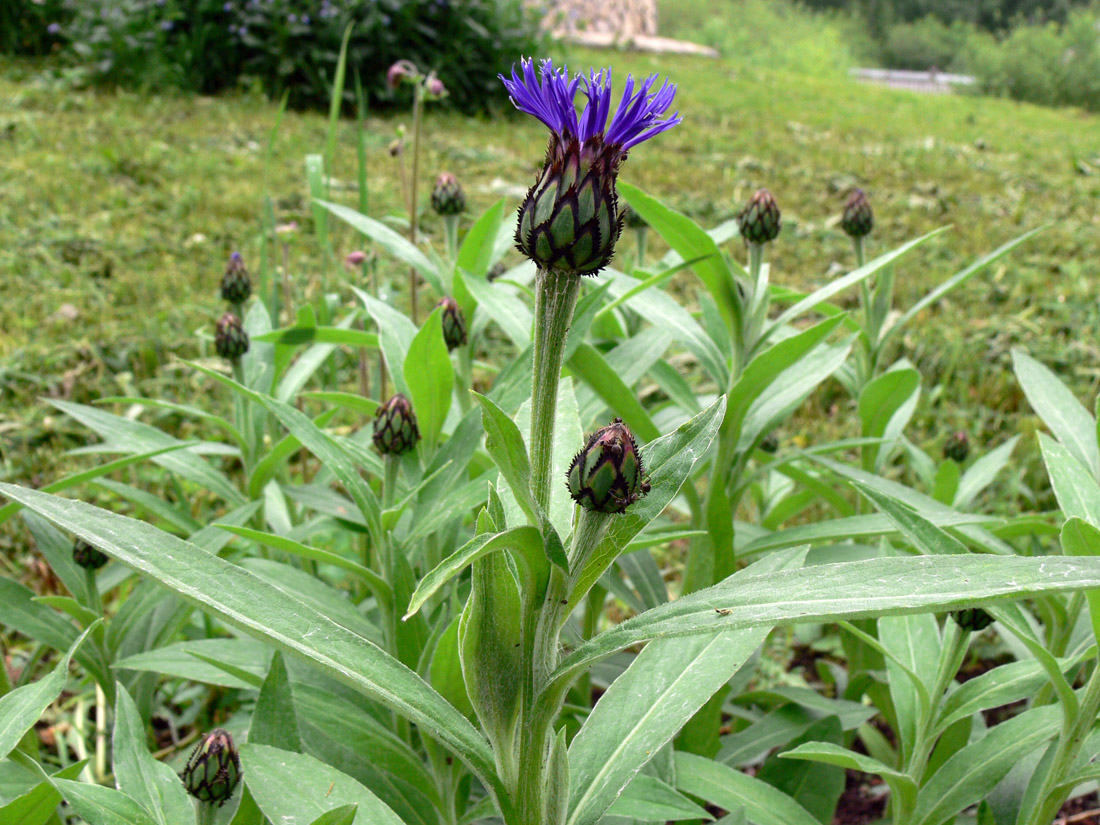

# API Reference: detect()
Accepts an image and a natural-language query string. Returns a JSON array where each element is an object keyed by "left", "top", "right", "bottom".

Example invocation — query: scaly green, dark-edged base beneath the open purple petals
[{"left": 516, "top": 134, "right": 623, "bottom": 275}]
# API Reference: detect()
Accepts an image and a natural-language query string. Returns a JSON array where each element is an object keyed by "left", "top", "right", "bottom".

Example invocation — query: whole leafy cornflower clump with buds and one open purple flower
[{"left": 0, "top": 55, "right": 1100, "bottom": 825}]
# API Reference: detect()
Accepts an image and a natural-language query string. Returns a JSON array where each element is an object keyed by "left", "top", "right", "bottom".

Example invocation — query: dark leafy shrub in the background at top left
[{"left": 27, "top": 0, "right": 538, "bottom": 111}]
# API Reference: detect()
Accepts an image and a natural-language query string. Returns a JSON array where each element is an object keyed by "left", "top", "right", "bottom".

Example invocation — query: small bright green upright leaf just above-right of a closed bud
[{"left": 404, "top": 307, "right": 454, "bottom": 454}]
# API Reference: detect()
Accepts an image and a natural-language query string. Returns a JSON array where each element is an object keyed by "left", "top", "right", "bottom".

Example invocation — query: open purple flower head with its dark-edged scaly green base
[{"left": 501, "top": 59, "right": 681, "bottom": 275}]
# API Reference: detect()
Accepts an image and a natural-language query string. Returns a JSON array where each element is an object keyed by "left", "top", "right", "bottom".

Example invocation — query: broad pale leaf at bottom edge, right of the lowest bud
[{"left": 241, "top": 743, "right": 404, "bottom": 825}]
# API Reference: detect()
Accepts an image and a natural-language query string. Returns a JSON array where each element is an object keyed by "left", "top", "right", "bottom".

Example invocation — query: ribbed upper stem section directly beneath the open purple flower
[{"left": 530, "top": 270, "right": 581, "bottom": 512}]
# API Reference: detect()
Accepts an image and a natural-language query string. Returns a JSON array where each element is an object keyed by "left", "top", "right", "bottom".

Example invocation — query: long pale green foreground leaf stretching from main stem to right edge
[{"left": 552, "top": 554, "right": 1100, "bottom": 680}]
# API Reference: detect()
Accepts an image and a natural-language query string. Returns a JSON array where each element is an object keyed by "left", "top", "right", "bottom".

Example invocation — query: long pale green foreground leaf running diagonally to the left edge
[{"left": 0, "top": 484, "right": 498, "bottom": 789}]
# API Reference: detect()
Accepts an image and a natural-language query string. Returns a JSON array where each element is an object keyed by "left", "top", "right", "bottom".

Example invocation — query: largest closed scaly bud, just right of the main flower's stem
[{"left": 565, "top": 418, "right": 649, "bottom": 513}]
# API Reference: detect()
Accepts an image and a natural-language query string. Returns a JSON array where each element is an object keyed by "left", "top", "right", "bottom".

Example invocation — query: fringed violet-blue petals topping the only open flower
[{"left": 499, "top": 58, "right": 683, "bottom": 153}]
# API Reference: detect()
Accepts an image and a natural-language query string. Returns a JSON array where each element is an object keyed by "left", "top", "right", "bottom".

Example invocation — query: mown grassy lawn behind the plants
[{"left": 0, "top": 42, "right": 1100, "bottom": 514}]
